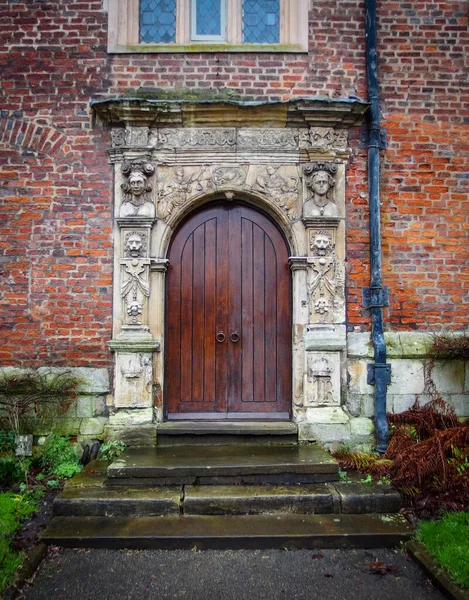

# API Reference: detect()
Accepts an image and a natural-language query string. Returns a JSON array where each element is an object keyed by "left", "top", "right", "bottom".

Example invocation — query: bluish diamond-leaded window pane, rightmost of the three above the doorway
[{"left": 243, "top": 0, "right": 280, "bottom": 44}]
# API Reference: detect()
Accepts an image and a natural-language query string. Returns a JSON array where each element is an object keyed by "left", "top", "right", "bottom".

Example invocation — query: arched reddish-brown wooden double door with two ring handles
[{"left": 166, "top": 202, "right": 291, "bottom": 420}]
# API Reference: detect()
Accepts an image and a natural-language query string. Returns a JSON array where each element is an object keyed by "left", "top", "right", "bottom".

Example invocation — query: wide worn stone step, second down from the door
[{"left": 107, "top": 444, "right": 338, "bottom": 486}]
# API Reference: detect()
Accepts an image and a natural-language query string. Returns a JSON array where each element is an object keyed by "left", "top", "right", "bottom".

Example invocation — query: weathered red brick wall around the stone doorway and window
[{"left": 0, "top": 0, "right": 469, "bottom": 366}]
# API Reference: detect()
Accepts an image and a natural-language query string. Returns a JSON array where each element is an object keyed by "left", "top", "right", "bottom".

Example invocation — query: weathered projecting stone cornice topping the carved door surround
[{"left": 91, "top": 98, "right": 368, "bottom": 128}]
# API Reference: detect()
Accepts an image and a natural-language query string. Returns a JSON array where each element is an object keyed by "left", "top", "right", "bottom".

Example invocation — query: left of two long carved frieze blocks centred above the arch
[{"left": 150, "top": 127, "right": 236, "bottom": 150}]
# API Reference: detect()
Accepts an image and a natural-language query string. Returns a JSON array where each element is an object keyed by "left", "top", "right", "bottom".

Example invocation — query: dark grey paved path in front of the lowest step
[{"left": 24, "top": 549, "right": 444, "bottom": 600}]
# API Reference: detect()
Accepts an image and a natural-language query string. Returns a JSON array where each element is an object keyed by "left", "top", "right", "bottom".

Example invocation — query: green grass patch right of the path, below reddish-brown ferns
[{"left": 417, "top": 512, "right": 469, "bottom": 590}]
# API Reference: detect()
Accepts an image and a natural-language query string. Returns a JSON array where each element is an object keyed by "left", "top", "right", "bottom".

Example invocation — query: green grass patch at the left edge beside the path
[{"left": 0, "top": 491, "right": 39, "bottom": 593}]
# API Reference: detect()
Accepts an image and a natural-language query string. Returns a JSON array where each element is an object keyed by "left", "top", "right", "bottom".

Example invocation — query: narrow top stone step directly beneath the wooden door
[{"left": 157, "top": 421, "right": 298, "bottom": 446}]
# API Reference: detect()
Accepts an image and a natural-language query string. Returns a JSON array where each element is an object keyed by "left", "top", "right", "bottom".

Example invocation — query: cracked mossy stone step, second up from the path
[{"left": 54, "top": 483, "right": 401, "bottom": 517}]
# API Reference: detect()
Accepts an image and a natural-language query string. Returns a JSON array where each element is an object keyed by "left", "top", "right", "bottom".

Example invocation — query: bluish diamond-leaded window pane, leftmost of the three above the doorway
[{"left": 140, "top": 0, "right": 176, "bottom": 44}]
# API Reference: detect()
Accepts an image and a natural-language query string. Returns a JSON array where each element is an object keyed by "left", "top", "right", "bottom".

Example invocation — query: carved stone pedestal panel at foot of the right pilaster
[{"left": 305, "top": 352, "right": 340, "bottom": 407}]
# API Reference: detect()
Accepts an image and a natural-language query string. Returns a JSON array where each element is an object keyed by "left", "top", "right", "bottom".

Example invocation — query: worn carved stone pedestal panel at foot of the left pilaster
[{"left": 115, "top": 352, "right": 153, "bottom": 408}]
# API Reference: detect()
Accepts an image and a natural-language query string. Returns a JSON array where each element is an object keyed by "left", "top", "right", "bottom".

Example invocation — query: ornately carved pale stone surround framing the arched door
[{"left": 95, "top": 101, "right": 366, "bottom": 439}]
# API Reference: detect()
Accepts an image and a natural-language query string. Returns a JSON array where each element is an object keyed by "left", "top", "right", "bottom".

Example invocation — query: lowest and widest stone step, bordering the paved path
[{"left": 42, "top": 514, "right": 412, "bottom": 549}]
